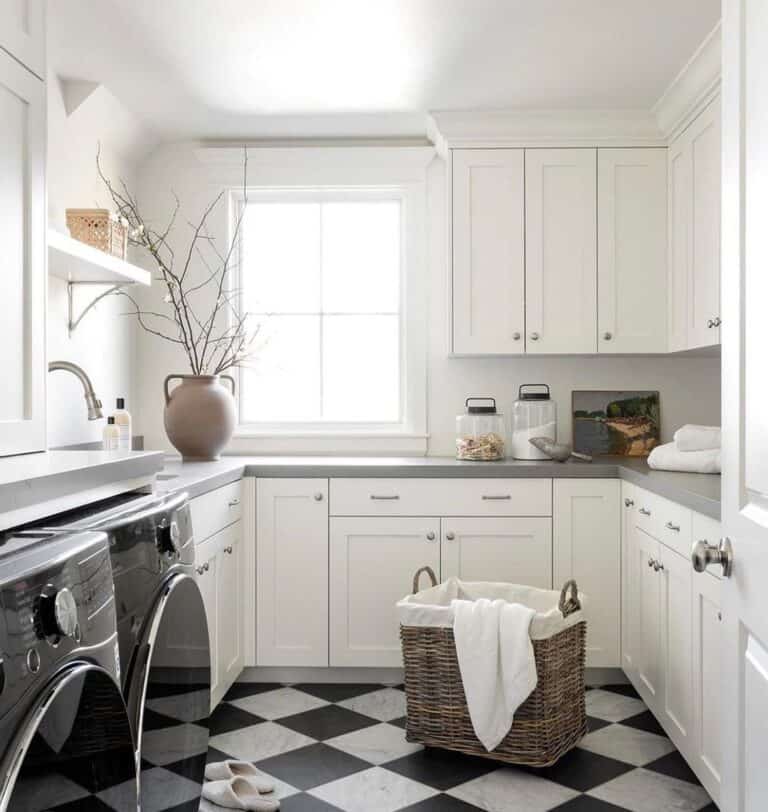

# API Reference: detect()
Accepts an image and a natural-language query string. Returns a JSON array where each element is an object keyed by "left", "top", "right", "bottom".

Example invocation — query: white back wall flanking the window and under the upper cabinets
[{"left": 138, "top": 145, "right": 720, "bottom": 455}]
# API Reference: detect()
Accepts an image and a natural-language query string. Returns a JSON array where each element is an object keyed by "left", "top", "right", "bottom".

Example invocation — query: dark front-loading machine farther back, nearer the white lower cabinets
[{"left": 35, "top": 493, "right": 211, "bottom": 812}]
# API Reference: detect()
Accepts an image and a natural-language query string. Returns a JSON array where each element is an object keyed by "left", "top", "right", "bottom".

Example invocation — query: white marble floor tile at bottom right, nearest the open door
[{"left": 588, "top": 769, "right": 710, "bottom": 812}]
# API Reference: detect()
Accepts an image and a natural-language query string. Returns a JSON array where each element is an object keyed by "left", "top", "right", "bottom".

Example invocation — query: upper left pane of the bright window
[{"left": 242, "top": 203, "right": 320, "bottom": 313}]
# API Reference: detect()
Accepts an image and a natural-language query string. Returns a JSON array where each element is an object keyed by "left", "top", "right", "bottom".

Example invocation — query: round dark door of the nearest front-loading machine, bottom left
[{"left": 0, "top": 663, "right": 138, "bottom": 812}]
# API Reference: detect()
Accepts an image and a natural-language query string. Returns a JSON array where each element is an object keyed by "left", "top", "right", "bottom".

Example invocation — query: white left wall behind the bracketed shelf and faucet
[{"left": 47, "top": 73, "right": 154, "bottom": 448}]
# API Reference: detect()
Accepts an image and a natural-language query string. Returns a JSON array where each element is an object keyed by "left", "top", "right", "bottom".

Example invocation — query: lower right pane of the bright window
[{"left": 323, "top": 316, "right": 400, "bottom": 422}]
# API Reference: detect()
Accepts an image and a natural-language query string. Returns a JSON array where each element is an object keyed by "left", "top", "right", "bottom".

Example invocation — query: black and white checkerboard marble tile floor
[{"left": 195, "top": 683, "right": 717, "bottom": 812}]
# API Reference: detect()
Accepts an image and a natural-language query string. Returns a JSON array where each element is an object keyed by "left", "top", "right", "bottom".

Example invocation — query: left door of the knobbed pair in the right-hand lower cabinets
[{"left": 633, "top": 526, "right": 662, "bottom": 711}]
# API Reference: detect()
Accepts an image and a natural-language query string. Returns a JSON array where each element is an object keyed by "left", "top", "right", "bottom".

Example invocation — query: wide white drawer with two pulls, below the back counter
[{"left": 330, "top": 478, "right": 552, "bottom": 516}]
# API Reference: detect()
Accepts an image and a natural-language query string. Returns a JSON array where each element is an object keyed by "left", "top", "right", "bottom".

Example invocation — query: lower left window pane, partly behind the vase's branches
[{"left": 240, "top": 316, "right": 320, "bottom": 423}]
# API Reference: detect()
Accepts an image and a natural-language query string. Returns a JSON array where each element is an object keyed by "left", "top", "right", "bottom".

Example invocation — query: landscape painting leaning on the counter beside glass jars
[{"left": 572, "top": 390, "right": 661, "bottom": 457}]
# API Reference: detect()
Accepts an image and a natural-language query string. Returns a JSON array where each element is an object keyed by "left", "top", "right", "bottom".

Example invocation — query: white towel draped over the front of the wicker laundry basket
[{"left": 451, "top": 598, "right": 537, "bottom": 752}]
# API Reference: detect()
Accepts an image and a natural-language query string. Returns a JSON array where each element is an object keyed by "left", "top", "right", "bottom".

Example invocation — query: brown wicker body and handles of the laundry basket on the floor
[{"left": 400, "top": 567, "right": 587, "bottom": 767}]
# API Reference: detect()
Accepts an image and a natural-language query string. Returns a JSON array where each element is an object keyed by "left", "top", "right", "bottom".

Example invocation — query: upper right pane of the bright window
[{"left": 323, "top": 201, "right": 400, "bottom": 313}]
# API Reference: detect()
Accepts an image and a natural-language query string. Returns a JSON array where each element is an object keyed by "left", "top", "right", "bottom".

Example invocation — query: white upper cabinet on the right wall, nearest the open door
[{"left": 669, "top": 96, "right": 721, "bottom": 351}]
